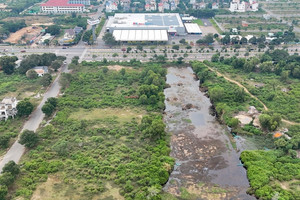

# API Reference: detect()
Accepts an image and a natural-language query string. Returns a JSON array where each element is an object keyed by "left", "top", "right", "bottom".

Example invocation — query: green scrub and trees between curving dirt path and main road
[{"left": 208, "top": 50, "right": 300, "bottom": 122}]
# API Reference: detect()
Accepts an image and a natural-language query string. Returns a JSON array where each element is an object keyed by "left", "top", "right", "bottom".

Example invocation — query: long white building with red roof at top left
[{"left": 41, "top": 0, "right": 84, "bottom": 14}]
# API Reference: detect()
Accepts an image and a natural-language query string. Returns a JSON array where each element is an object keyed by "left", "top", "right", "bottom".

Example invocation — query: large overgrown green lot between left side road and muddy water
[{"left": 10, "top": 63, "right": 174, "bottom": 200}]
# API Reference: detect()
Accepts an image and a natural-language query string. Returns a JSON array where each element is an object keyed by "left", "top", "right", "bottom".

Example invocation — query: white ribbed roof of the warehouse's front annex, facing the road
[{"left": 113, "top": 30, "right": 168, "bottom": 41}]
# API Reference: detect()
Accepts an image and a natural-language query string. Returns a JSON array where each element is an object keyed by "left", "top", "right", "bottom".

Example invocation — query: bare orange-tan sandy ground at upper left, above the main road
[{"left": 4, "top": 26, "right": 42, "bottom": 44}]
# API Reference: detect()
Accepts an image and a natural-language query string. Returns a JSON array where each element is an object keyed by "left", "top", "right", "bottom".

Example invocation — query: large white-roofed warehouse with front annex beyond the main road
[{"left": 106, "top": 13, "right": 186, "bottom": 42}]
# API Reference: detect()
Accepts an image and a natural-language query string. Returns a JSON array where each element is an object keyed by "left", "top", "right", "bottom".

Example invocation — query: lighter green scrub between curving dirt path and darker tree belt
[{"left": 205, "top": 60, "right": 300, "bottom": 122}]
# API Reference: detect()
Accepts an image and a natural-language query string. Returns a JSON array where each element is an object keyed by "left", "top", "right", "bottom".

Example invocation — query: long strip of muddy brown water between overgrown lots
[{"left": 164, "top": 67, "right": 254, "bottom": 200}]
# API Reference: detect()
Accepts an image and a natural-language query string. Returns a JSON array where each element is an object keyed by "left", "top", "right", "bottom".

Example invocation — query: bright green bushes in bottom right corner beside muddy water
[{"left": 241, "top": 150, "right": 300, "bottom": 200}]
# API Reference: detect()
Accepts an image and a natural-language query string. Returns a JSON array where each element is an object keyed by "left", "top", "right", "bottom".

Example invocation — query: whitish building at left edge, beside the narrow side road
[{"left": 0, "top": 97, "right": 18, "bottom": 121}]
